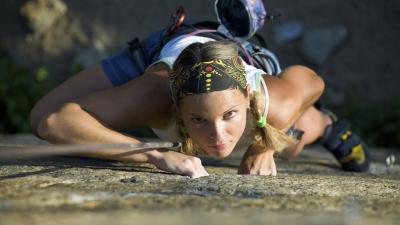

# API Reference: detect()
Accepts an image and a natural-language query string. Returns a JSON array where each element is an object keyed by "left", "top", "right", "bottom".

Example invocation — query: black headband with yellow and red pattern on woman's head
[{"left": 170, "top": 57, "right": 246, "bottom": 99}]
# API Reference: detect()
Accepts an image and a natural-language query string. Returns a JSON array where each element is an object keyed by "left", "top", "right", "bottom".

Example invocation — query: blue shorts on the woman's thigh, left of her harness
[{"left": 101, "top": 30, "right": 165, "bottom": 86}]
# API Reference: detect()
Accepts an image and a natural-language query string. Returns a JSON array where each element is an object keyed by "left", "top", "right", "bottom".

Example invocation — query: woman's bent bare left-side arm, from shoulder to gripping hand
[{"left": 32, "top": 62, "right": 208, "bottom": 177}]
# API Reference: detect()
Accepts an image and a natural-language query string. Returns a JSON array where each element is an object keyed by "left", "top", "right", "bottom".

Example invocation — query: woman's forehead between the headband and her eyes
[{"left": 179, "top": 89, "right": 246, "bottom": 114}]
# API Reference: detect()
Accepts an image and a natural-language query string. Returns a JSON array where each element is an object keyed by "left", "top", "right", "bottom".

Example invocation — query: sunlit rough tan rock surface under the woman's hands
[{"left": 0, "top": 136, "right": 400, "bottom": 225}]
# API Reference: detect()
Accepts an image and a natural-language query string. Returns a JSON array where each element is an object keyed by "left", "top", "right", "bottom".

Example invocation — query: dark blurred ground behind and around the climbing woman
[{"left": 0, "top": 0, "right": 400, "bottom": 148}]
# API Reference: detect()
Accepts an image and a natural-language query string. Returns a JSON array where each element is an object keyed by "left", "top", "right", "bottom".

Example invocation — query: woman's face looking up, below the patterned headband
[{"left": 179, "top": 89, "right": 249, "bottom": 158}]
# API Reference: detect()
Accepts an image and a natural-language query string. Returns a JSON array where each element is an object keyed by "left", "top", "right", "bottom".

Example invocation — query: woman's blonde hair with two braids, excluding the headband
[{"left": 172, "top": 41, "right": 294, "bottom": 155}]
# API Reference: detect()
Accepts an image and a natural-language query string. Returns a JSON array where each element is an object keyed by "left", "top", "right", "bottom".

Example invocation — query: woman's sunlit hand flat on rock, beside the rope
[{"left": 150, "top": 151, "right": 208, "bottom": 178}]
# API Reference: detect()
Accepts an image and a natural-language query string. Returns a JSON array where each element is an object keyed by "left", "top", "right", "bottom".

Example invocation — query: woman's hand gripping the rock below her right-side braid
[{"left": 238, "top": 145, "right": 276, "bottom": 176}]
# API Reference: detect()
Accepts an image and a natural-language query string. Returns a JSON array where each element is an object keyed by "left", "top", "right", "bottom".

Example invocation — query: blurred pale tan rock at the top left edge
[{"left": 20, "top": 0, "right": 67, "bottom": 33}]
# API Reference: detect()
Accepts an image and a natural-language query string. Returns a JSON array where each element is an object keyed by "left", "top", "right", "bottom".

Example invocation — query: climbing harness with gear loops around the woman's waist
[{"left": 125, "top": 1, "right": 281, "bottom": 76}]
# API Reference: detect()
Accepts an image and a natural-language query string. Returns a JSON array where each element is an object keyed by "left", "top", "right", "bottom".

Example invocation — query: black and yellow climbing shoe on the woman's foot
[{"left": 321, "top": 119, "right": 371, "bottom": 172}]
